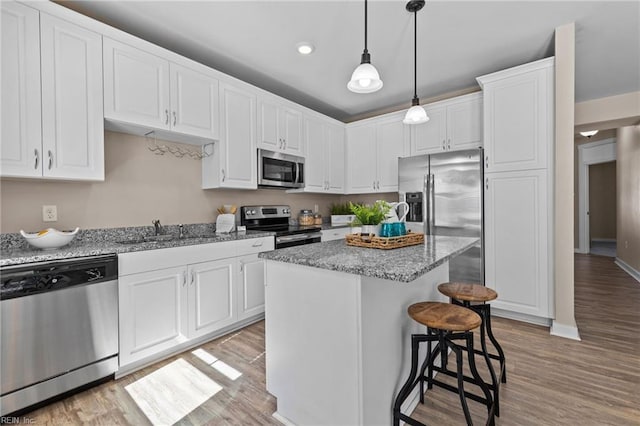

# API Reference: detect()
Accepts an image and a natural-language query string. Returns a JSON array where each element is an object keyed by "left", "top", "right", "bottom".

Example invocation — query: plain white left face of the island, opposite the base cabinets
[{"left": 265, "top": 260, "right": 363, "bottom": 426}]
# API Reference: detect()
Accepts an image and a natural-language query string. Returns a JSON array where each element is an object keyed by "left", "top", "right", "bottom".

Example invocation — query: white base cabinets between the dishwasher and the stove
[{"left": 118, "top": 237, "right": 274, "bottom": 374}]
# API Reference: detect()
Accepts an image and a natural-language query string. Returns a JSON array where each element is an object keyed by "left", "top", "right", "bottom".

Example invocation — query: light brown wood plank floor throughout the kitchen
[{"left": 25, "top": 255, "right": 640, "bottom": 426}]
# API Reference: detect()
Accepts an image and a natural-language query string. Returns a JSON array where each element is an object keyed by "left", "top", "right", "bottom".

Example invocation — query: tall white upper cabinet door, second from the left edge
[{"left": 40, "top": 13, "right": 104, "bottom": 180}]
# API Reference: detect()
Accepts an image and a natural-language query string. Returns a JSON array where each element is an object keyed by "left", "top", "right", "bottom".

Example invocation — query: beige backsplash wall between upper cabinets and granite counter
[{"left": 0, "top": 132, "right": 397, "bottom": 233}]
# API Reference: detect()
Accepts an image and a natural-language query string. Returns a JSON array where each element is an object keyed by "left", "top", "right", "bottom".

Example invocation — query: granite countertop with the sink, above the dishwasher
[{"left": 0, "top": 228, "right": 274, "bottom": 266}]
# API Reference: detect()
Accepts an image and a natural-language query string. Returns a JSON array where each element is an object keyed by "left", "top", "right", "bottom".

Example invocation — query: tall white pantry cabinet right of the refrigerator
[{"left": 478, "top": 58, "right": 554, "bottom": 325}]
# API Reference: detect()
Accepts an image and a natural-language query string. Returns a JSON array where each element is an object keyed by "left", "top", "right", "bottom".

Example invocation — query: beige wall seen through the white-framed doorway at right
[{"left": 589, "top": 161, "right": 616, "bottom": 240}]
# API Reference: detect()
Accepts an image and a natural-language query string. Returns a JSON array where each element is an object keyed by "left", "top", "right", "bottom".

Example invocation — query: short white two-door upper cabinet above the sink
[{"left": 104, "top": 37, "right": 219, "bottom": 140}]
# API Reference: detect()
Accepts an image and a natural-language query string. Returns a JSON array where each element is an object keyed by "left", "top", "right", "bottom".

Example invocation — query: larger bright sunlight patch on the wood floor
[{"left": 125, "top": 359, "right": 222, "bottom": 425}]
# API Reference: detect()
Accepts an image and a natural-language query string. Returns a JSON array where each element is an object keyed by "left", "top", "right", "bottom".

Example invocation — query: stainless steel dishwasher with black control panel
[{"left": 0, "top": 255, "right": 118, "bottom": 416}]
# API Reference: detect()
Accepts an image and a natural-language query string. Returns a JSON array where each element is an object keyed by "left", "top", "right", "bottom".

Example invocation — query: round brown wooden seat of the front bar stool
[{"left": 407, "top": 302, "right": 482, "bottom": 331}]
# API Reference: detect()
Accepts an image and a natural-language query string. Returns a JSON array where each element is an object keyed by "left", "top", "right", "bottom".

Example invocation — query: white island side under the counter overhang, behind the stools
[{"left": 361, "top": 262, "right": 449, "bottom": 426}]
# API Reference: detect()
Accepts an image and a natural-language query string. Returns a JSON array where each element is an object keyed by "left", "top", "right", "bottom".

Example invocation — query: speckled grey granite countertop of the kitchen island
[{"left": 259, "top": 235, "right": 478, "bottom": 283}]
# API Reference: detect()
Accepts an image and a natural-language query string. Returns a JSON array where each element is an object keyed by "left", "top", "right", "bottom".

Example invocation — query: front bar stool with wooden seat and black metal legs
[{"left": 393, "top": 302, "right": 495, "bottom": 426}]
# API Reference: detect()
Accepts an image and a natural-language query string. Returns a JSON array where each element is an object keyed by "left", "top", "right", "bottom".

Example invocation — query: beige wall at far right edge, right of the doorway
[{"left": 616, "top": 126, "right": 640, "bottom": 271}]
